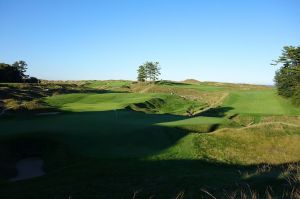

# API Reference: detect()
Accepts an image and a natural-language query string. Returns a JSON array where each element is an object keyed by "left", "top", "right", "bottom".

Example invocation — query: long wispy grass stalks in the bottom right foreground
[{"left": 132, "top": 163, "right": 300, "bottom": 199}]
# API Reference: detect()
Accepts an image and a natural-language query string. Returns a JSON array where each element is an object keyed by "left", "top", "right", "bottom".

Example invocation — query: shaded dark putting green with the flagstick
[{"left": 0, "top": 110, "right": 188, "bottom": 158}]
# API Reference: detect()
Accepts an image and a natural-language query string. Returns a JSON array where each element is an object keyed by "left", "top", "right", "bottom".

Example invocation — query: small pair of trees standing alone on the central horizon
[{"left": 138, "top": 62, "right": 160, "bottom": 82}]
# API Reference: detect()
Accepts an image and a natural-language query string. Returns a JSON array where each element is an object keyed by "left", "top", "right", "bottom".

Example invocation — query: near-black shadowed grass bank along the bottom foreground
[{"left": 0, "top": 157, "right": 297, "bottom": 199}]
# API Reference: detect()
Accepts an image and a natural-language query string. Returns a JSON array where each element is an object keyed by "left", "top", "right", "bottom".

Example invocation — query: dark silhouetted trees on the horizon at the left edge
[{"left": 0, "top": 60, "right": 39, "bottom": 83}]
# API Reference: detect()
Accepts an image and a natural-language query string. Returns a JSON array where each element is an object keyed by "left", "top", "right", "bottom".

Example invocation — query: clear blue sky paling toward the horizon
[{"left": 0, "top": 0, "right": 300, "bottom": 84}]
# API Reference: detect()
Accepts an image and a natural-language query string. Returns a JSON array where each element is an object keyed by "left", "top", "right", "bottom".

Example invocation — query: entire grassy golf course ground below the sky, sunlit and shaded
[{"left": 0, "top": 80, "right": 300, "bottom": 198}]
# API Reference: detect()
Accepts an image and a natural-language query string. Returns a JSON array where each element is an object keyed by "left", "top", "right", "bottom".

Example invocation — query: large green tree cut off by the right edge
[{"left": 272, "top": 46, "right": 300, "bottom": 105}]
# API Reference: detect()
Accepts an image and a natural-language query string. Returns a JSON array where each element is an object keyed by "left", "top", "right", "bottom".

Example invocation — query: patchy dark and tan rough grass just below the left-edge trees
[{"left": 0, "top": 81, "right": 107, "bottom": 112}]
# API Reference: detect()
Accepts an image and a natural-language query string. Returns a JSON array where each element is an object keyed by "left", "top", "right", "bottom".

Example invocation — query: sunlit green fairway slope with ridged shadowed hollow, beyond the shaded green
[{"left": 45, "top": 93, "right": 209, "bottom": 115}]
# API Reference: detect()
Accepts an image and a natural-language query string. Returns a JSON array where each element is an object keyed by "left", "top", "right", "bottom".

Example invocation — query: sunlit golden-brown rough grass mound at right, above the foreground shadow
[{"left": 195, "top": 124, "right": 300, "bottom": 164}]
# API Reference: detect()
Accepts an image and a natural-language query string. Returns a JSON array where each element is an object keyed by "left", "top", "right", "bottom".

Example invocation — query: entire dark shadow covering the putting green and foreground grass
[{"left": 0, "top": 110, "right": 298, "bottom": 199}]
